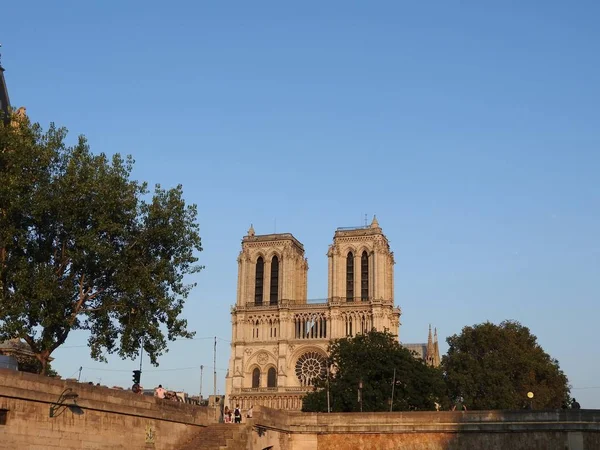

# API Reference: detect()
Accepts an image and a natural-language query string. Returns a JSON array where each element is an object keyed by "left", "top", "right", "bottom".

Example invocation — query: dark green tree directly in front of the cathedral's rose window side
[{"left": 303, "top": 331, "right": 447, "bottom": 412}]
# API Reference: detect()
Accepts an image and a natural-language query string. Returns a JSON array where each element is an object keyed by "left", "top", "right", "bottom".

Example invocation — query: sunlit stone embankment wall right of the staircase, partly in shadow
[{"left": 248, "top": 407, "right": 600, "bottom": 450}]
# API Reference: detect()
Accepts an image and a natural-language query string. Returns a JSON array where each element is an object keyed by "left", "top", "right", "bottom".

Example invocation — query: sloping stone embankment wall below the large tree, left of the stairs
[{"left": 0, "top": 370, "right": 216, "bottom": 450}]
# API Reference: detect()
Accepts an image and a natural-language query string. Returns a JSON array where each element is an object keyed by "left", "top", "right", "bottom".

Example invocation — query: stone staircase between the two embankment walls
[{"left": 181, "top": 423, "right": 252, "bottom": 450}]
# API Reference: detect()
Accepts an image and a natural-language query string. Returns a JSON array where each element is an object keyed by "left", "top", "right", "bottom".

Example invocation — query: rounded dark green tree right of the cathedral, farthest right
[{"left": 442, "top": 321, "right": 569, "bottom": 409}]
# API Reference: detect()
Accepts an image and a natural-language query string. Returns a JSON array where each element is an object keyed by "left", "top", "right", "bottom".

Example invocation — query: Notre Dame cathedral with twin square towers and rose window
[{"left": 225, "top": 218, "right": 440, "bottom": 410}]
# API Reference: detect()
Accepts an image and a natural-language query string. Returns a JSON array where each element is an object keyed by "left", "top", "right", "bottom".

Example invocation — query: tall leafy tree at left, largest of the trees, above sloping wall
[{"left": 0, "top": 113, "right": 202, "bottom": 373}]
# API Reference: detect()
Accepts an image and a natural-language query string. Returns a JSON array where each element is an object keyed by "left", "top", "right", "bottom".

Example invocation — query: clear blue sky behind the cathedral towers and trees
[{"left": 0, "top": 1, "right": 600, "bottom": 408}]
